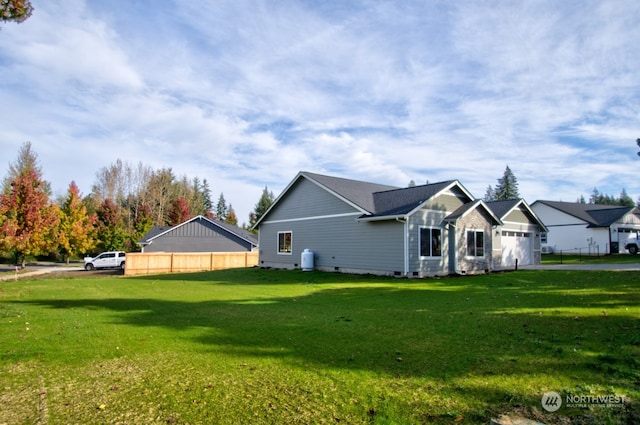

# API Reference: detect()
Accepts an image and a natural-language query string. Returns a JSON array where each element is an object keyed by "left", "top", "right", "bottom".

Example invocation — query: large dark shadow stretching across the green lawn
[{"left": 10, "top": 272, "right": 640, "bottom": 391}]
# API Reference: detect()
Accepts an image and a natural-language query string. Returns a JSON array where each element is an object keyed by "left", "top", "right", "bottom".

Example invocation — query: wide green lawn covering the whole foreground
[{"left": 0, "top": 269, "right": 640, "bottom": 424}]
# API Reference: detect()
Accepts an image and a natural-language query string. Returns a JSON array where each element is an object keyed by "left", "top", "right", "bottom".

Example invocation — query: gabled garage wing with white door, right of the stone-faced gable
[{"left": 487, "top": 199, "right": 547, "bottom": 268}]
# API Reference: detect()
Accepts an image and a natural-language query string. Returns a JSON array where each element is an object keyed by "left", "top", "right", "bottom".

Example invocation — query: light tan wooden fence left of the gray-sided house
[{"left": 124, "top": 251, "right": 258, "bottom": 276}]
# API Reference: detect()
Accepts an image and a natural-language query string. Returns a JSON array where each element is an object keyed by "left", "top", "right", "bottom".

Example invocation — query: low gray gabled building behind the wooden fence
[{"left": 138, "top": 215, "right": 258, "bottom": 252}]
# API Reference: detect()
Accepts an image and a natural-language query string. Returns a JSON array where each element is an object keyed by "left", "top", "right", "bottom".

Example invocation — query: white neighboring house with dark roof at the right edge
[{"left": 531, "top": 201, "right": 640, "bottom": 255}]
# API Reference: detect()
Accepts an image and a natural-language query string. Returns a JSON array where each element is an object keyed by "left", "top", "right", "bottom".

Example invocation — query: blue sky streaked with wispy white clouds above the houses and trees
[{"left": 0, "top": 0, "right": 640, "bottom": 222}]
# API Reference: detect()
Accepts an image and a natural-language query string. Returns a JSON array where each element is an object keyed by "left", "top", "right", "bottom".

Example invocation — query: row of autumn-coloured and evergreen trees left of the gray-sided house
[{"left": 0, "top": 142, "right": 274, "bottom": 267}]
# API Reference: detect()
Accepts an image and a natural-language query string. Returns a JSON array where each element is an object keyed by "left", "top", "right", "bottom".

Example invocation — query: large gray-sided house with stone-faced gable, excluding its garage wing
[{"left": 256, "top": 172, "right": 540, "bottom": 277}]
